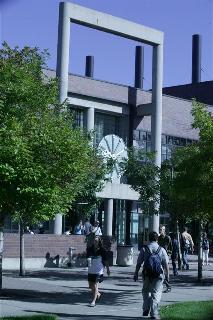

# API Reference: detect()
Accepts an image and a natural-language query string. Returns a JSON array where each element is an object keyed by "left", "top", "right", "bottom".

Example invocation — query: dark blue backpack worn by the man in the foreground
[{"left": 143, "top": 246, "right": 163, "bottom": 278}]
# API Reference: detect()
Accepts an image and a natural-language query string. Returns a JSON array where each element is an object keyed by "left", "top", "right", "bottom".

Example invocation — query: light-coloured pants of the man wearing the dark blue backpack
[{"left": 142, "top": 277, "right": 164, "bottom": 317}]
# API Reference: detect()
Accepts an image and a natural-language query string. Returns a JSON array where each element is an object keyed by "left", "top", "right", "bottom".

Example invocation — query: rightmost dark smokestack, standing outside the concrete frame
[{"left": 192, "top": 34, "right": 201, "bottom": 83}]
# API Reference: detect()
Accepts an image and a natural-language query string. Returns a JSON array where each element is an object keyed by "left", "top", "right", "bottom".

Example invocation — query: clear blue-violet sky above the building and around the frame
[{"left": 0, "top": 0, "right": 213, "bottom": 89}]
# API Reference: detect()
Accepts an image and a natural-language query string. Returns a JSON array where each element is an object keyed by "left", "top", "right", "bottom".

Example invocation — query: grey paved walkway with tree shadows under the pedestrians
[{"left": 0, "top": 256, "right": 213, "bottom": 320}]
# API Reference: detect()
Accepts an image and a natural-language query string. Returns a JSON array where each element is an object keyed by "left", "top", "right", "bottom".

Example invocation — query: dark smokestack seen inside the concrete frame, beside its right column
[{"left": 135, "top": 46, "right": 144, "bottom": 89}]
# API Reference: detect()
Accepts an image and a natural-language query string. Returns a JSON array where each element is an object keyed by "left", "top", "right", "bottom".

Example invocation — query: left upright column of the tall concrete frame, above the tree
[{"left": 56, "top": 2, "right": 70, "bottom": 103}]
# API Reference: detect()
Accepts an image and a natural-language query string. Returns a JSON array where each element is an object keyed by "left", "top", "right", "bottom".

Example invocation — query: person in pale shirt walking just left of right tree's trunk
[{"left": 181, "top": 227, "right": 194, "bottom": 270}]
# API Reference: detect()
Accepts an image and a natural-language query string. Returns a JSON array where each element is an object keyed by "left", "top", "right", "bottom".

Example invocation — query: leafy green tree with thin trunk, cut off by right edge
[{"left": 162, "top": 101, "right": 213, "bottom": 279}]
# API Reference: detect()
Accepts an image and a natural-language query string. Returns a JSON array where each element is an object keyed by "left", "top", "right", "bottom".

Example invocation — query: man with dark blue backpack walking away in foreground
[{"left": 134, "top": 231, "right": 169, "bottom": 319}]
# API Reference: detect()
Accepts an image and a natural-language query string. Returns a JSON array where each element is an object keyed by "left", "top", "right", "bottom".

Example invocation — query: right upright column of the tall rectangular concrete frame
[{"left": 151, "top": 45, "right": 163, "bottom": 232}]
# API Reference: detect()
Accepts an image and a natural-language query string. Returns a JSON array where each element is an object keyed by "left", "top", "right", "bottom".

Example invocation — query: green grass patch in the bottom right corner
[{"left": 160, "top": 300, "right": 213, "bottom": 320}]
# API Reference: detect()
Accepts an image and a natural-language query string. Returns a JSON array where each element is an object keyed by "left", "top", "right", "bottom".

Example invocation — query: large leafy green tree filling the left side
[{"left": 0, "top": 43, "right": 105, "bottom": 280}]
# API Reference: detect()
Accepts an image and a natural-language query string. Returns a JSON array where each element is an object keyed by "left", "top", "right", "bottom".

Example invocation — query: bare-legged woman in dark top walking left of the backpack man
[{"left": 87, "top": 233, "right": 110, "bottom": 307}]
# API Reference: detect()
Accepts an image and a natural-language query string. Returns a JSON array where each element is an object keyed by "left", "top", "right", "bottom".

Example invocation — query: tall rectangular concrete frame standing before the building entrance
[{"left": 57, "top": 2, "right": 163, "bottom": 231}]
